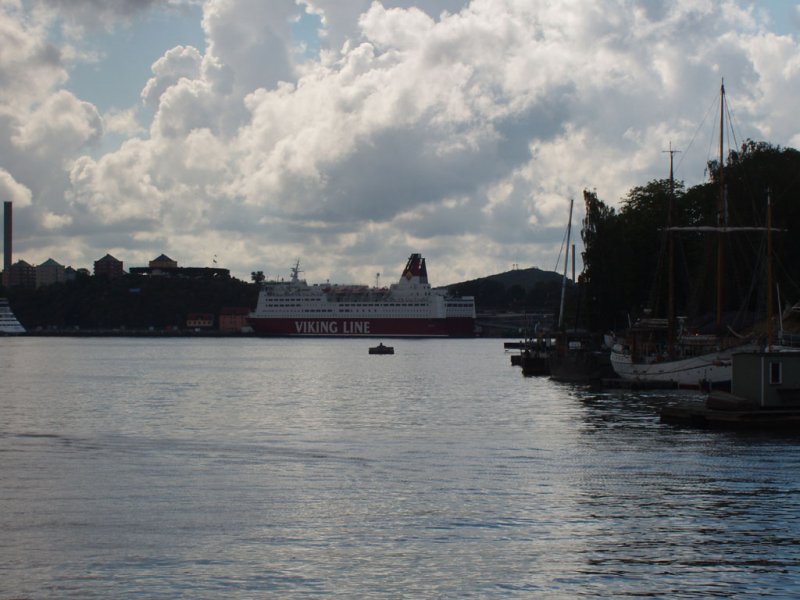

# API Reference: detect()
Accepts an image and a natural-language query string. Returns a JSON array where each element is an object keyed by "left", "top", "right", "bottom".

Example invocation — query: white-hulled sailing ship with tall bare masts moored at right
[{"left": 611, "top": 82, "right": 771, "bottom": 389}]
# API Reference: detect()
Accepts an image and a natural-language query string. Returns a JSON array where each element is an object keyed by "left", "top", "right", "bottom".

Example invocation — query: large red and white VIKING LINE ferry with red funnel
[{"left": 248, "top": 254, "right": 475, "bottom": 337}]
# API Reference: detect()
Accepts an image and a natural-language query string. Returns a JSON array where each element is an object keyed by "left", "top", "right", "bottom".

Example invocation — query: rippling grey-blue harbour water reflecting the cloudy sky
[{"left": 0, "top": 338, "right": 800, "bottom": 599}]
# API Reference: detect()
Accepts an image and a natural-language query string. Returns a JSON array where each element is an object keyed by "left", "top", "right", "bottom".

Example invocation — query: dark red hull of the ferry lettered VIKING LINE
[{"left": 248, "top": 317, "right": 474, "bottom": 337}]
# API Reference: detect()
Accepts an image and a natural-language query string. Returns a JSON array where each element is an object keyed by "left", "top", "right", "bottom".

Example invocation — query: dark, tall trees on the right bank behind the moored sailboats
[{"left": 571, "top": 140, "right": 800, "bottom": 331}]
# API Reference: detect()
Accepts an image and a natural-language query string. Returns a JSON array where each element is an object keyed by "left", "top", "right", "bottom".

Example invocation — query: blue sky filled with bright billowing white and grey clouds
[{"left": 0, "top": 0, "right": 800, "bottom": 285}]
